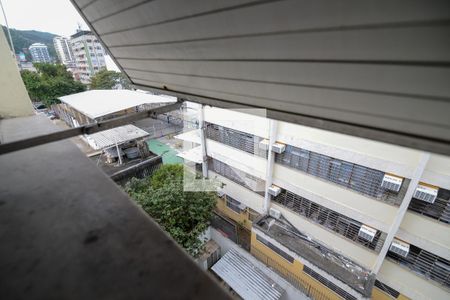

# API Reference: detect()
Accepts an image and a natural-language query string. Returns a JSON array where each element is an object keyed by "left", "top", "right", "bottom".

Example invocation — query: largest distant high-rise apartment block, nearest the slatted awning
[{"left": 70, "top": 30, "right": 106, "bottom": 84}]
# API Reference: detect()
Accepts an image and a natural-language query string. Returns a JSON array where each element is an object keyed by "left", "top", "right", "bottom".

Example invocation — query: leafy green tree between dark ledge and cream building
[{"left": 125, "top": 165, "right": 216, "bottom": 256}]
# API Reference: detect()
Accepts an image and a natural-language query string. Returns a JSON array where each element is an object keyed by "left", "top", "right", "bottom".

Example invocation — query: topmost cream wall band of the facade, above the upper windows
[{"left": 205, "top": 107, "right": 450, "bottom": 189}]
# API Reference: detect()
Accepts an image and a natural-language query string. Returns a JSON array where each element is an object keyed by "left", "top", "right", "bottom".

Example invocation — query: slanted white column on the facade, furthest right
[{"left": 371, "top": 153, "right": 430, "bottom": 275}]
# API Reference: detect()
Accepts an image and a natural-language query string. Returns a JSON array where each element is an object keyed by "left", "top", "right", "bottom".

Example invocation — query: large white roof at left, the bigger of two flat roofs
[{"left": 59, "top": 90, "right": 177, "bottom": 119}]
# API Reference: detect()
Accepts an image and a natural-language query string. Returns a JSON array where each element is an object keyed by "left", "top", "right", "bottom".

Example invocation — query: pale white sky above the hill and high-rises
[{"left": 0, "top": 0, "right": 88, "bottom": 36}]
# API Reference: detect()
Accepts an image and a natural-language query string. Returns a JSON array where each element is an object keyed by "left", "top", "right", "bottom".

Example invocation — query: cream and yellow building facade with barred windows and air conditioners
[{"left": 181, "top": 107, "right": 450, "bottom": 299}]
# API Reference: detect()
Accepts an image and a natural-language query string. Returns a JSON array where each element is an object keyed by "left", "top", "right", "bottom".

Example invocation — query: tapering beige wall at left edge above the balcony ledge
[{"left": 0, "top": 30, "right": 33, "bottom": 118}]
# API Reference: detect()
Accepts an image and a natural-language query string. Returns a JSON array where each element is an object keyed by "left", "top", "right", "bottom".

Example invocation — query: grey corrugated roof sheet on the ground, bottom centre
[{"left": 211, "top": 249, "right": 284, "bottom": 300}]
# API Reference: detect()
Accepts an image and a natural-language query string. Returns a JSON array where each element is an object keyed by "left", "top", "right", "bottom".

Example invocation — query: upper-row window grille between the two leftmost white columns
[{"left": 205, "top": 122, "right": 267, "bottom": 157}]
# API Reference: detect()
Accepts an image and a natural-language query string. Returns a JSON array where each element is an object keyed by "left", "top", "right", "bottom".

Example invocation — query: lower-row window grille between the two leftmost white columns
[{"left": 208, "top": 158, "right": 265, "bottom": 195}]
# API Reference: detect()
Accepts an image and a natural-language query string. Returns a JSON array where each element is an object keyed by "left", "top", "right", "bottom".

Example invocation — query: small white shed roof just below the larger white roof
[{"left": 85, "top": 124, "right": 149, "bottom": 150}]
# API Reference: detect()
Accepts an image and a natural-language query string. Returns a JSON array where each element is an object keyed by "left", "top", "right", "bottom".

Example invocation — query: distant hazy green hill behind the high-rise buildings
[{"left": 2, "top": 25, "right": 58, "bottom": 61}]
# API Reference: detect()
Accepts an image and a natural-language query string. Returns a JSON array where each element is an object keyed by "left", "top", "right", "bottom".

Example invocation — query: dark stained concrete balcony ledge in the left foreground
[{"left": 0, "top": 116, "right": 229, "bottom": 299}]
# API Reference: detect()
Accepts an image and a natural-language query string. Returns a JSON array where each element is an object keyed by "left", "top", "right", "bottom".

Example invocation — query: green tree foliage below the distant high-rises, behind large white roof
[{"left": 20, "top": 63, "right": 86, "bottom": 107}]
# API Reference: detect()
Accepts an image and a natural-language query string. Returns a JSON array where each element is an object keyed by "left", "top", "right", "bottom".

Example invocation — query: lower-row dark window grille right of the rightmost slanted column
[{"left": 387, "top": 245, "right": 450, "bottom": 287}]
